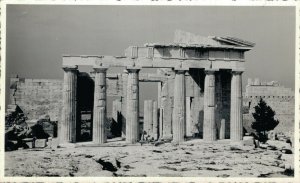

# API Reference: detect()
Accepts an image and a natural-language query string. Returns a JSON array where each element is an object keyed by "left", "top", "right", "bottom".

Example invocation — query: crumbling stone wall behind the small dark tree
[{"left": 243, "top": 79, "right": 295, "bottom": 136}]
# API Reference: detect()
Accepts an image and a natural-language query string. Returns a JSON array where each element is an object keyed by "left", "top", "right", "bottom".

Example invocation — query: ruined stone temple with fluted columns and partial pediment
[{"left": 59, "top": 31, "right": 254, "bottom": 144}]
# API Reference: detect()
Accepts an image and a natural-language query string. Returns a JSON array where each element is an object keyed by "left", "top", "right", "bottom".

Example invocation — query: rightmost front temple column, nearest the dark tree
[{"left": 230, "top": 71, "right": 243, "bottom": 141}]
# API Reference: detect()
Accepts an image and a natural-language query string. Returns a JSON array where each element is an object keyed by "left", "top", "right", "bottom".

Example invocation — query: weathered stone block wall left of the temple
[{"left": 10, "top": 78, "right": 62, "bottom": 121}]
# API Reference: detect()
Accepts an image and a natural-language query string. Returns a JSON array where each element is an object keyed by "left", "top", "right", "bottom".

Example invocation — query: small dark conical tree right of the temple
[{"left": 251, "top": 98, "right": 279, "bottom": 142}]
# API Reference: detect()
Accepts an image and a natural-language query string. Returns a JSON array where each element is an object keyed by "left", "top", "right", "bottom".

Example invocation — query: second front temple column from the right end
[{"left": 203, "top": 70, "right": 217, "bottom": 141}]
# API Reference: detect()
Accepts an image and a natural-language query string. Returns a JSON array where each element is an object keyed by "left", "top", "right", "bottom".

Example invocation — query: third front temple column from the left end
[{"left": 126, "top": 68, "right": 140, "bottom": 143}]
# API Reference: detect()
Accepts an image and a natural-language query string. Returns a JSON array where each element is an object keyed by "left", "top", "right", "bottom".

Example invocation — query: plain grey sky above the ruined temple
[{"left": 6, "top": 5, "right": 295, "bottom": 110}]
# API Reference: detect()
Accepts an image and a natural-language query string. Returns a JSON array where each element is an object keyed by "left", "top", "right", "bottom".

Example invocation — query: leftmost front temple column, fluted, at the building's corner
[{"left": 60, "top": 66, "right": 77, "bottom": 144}]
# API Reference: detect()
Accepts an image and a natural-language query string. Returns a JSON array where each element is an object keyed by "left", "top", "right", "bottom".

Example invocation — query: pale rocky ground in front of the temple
[{"left": 5, "top": 140, "right": 293, "bottom": 177}]
